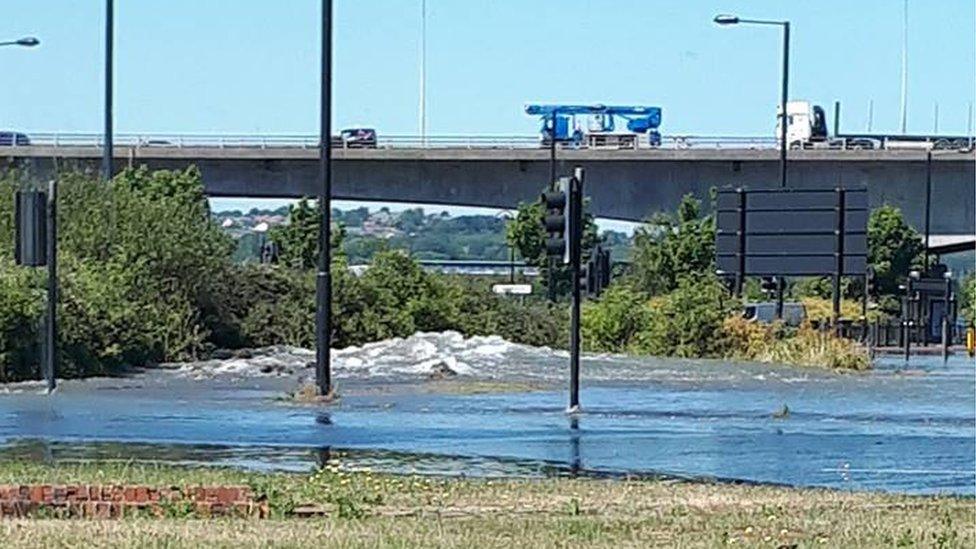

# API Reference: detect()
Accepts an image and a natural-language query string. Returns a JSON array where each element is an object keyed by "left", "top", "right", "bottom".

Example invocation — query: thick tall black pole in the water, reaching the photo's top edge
[{"left": 315, "top": 0, "right": 340, "bottom": 396}]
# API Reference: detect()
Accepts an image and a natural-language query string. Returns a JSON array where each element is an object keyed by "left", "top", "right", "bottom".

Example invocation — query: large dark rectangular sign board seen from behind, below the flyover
[{"left": 715, "top": 187, "right": 868, "bottom": 279}]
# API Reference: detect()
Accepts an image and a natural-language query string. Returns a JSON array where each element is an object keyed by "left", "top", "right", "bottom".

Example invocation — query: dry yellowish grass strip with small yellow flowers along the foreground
[{"left": 0, "top": 456, "right": 976, "bottom": 547}]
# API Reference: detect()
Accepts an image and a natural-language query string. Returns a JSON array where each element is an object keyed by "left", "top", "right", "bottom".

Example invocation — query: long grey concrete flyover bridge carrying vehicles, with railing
[{"left": 0, "top": 135, "right": 976, "bottom": 235}]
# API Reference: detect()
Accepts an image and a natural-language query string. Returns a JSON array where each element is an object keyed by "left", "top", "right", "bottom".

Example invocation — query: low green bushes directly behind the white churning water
[{"left": 241, "top": 251, "right": 567, "bottom": 347}]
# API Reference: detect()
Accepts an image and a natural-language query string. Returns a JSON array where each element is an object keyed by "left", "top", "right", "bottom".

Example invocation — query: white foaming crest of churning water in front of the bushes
[{"left": 160, "top": 331, "right": 868, "bottom": 386}]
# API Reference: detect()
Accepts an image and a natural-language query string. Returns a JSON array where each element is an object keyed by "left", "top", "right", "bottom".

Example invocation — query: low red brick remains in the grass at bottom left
[{"left": 0, "top": 484, "right": 268, "bottom": 518}]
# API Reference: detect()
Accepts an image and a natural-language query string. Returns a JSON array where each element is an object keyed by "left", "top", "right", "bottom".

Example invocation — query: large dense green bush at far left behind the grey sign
[{"left": 0, "top": 168, "right": 233, "bottom": 379}]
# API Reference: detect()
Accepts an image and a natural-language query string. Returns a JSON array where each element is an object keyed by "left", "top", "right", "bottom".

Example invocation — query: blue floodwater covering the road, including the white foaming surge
[{"left": 0, "top": 334, "right": 976, "bottom": 495}]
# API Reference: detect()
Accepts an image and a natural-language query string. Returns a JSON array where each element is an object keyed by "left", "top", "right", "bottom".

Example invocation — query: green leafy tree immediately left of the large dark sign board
[{"left": 631, "top": 194, "right": 715, "bottom": 295}]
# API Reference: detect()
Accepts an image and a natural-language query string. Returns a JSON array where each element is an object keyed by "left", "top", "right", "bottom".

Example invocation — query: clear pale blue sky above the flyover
[{"left": 0, "top": 0, "right": 976, "bottom": 135}]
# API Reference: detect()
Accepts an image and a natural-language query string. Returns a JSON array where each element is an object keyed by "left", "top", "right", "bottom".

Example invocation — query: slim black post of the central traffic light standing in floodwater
[{"left": 566, "top": 167, "right": 583, "bottom": 413}]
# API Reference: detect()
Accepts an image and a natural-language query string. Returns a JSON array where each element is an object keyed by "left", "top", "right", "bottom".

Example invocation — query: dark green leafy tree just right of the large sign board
[{"left": 868, "top": 205, "right": 924, "bottom": 295}]
